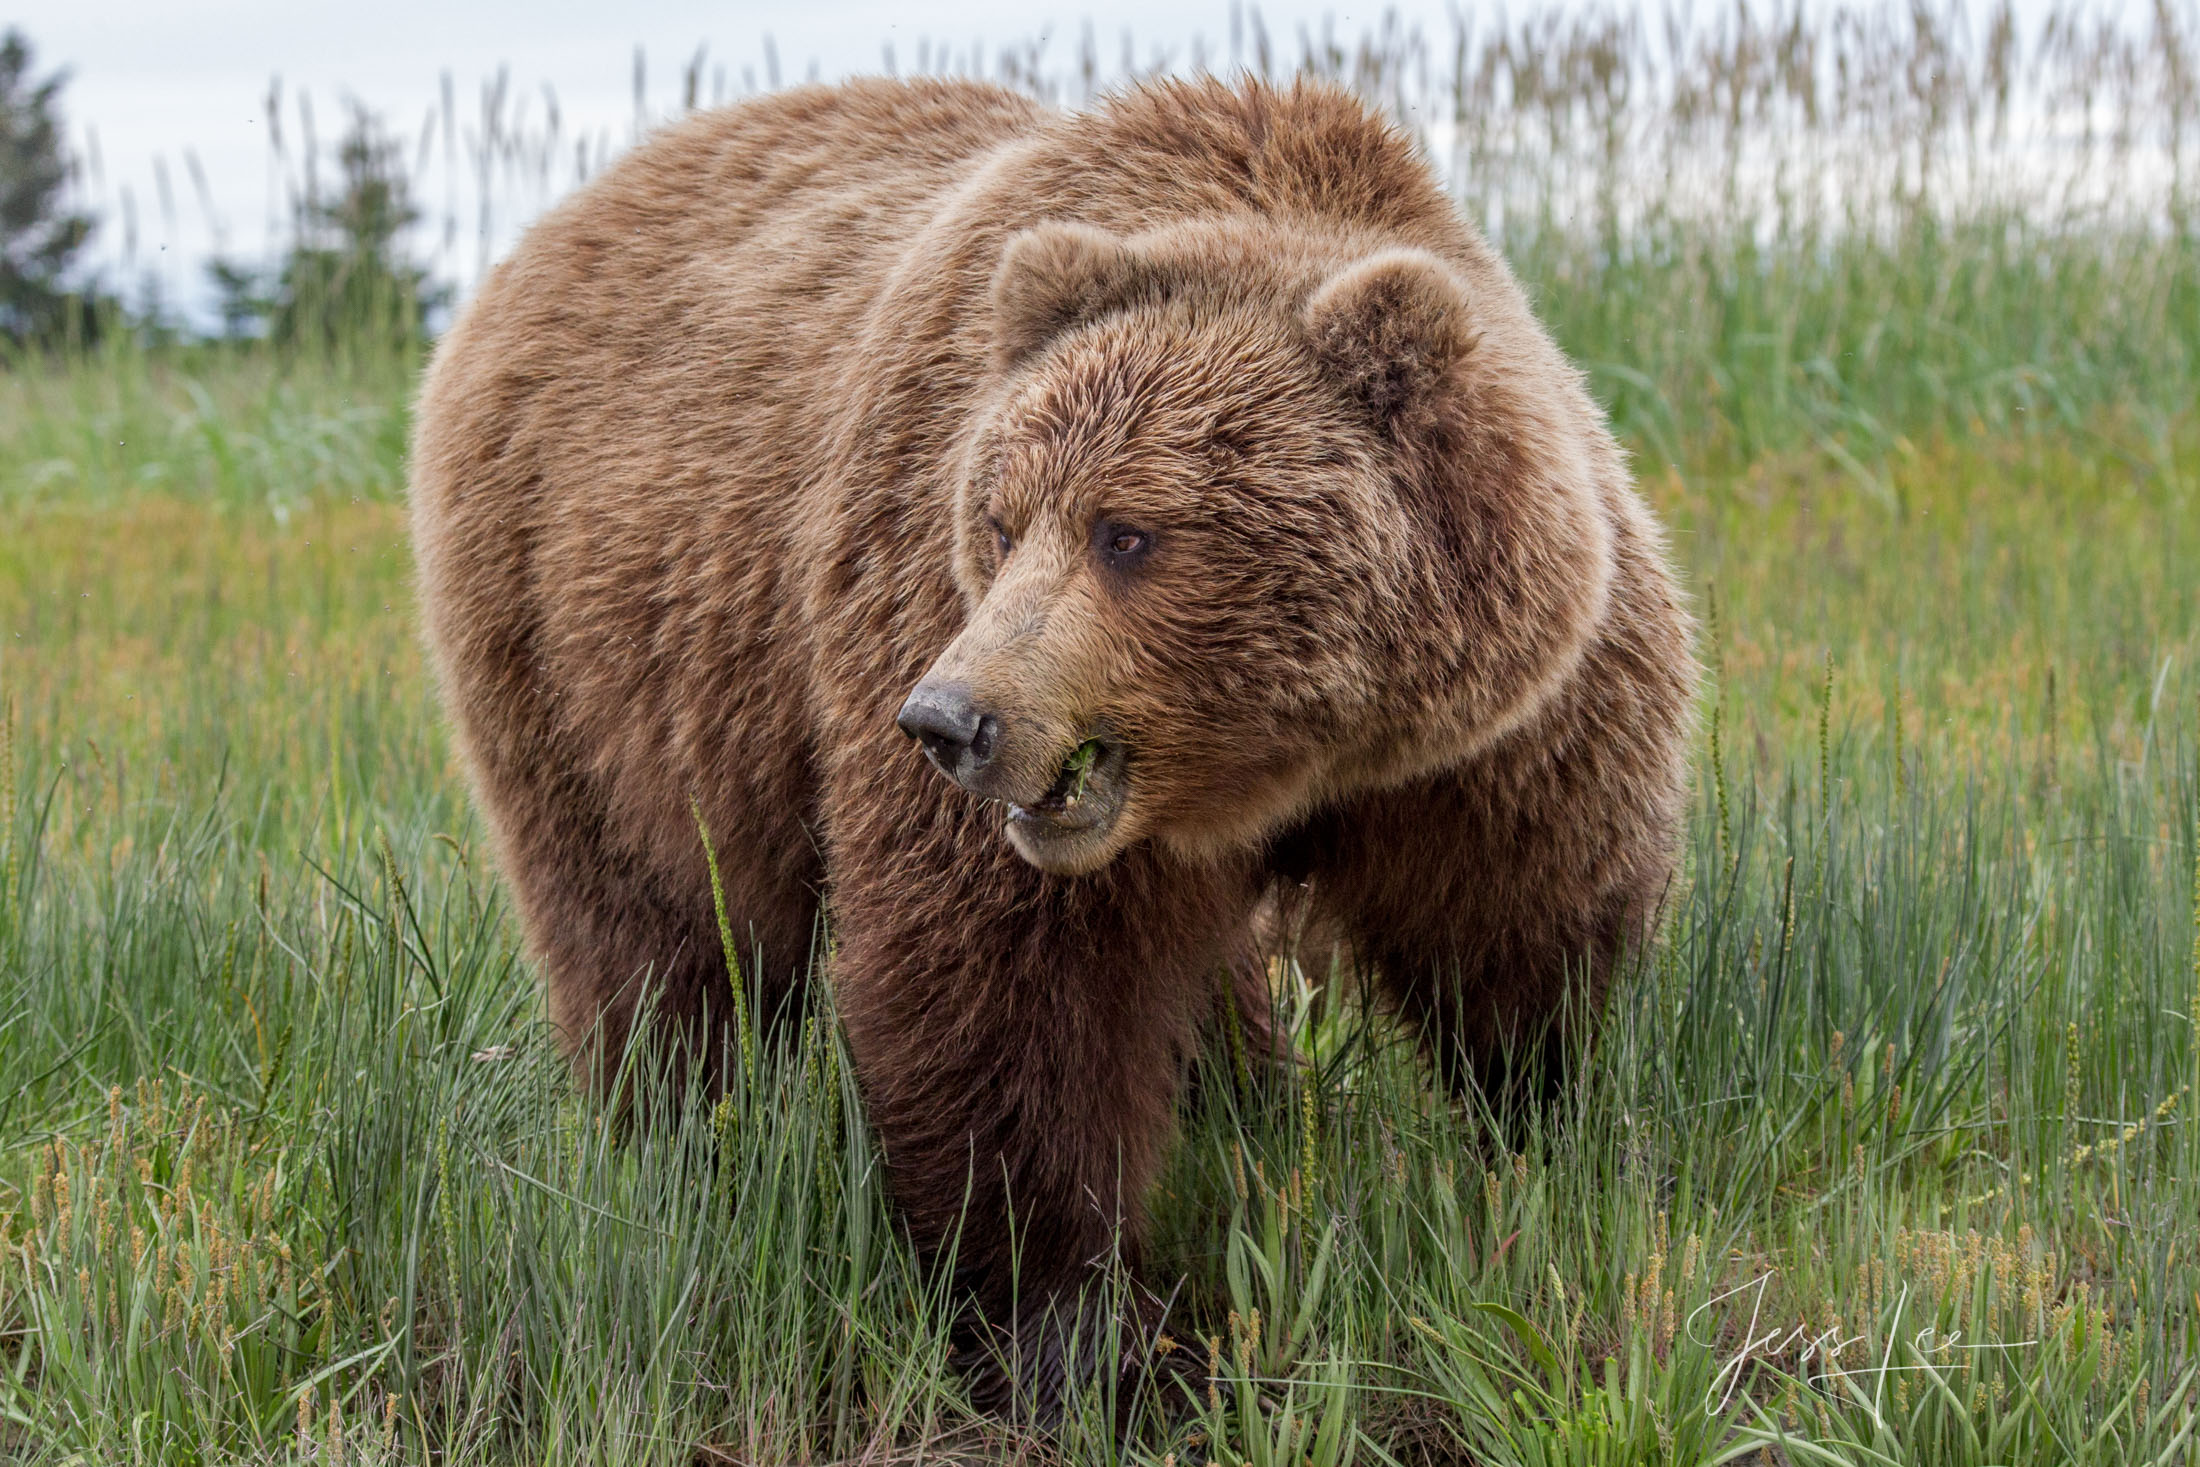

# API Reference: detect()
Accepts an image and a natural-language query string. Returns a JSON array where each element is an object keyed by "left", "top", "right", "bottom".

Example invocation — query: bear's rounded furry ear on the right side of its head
[{"left": 1302, "top": 249, "right": 1474, "bottom": 429}]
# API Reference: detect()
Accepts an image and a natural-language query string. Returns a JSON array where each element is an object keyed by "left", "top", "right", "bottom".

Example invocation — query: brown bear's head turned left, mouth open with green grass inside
[{"left": 900, "top": 220, "right": 1621, "bottom": 873}]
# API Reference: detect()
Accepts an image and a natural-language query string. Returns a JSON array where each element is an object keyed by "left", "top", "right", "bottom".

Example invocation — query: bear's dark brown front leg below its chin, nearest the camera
[{"left": 832, "top": 792, "right": 1247, "bottom": 1421}]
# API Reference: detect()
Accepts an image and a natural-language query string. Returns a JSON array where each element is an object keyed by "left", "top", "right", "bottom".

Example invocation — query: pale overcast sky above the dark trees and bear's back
[{"left": 17, "top": 0, "right": 1460, "bottom": 315}]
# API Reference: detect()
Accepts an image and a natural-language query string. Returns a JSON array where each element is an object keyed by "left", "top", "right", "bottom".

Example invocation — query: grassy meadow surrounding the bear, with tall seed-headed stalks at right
[{"left": 0, "top": 4, "right": 2200, "bottom": 1467}]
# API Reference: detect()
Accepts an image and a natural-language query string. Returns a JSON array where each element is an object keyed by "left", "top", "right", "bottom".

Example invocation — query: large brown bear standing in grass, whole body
[{"left": 411, "top": 81, "right": 1696, "bottom": 1410}]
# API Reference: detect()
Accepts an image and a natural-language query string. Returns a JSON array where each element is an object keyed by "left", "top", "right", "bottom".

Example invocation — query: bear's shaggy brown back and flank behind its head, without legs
[{"left": 414, "top": 79, "right": 1592, "bottom": 998}]
